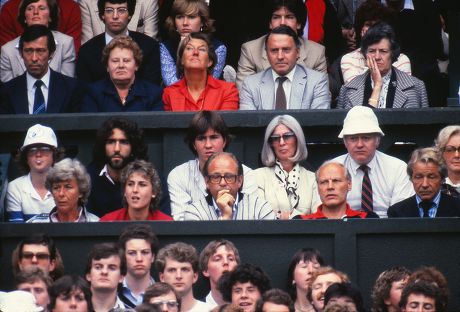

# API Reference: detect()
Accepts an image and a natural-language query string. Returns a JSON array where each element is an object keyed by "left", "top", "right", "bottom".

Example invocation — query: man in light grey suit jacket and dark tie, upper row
[{"left": 240, "top": 25, "right": 331, "bottom": 110}]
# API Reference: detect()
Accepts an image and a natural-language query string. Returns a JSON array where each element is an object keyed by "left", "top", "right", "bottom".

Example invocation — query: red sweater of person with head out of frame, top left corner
[{"left": 0, "top": 0, "right": 81, "bottom": 54}]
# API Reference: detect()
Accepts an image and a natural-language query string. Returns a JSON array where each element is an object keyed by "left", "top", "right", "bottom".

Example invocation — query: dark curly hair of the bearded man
[{"left": 93, "top": 117, "right": 148, "bottom": 166}]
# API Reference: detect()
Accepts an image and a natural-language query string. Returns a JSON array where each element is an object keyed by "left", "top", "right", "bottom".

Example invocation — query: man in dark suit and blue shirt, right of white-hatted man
[{"left": 388, "top": 147, "right": 460, "bottom": 218}]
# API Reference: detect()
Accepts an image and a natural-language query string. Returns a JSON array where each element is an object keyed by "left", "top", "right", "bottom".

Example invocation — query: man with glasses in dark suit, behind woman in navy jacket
[{"left": 76, "top": 0, "right": 161, "bottom": 85}]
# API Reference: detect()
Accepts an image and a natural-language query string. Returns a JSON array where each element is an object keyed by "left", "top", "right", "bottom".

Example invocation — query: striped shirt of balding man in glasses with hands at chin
[{"left": 184, "top": 193, "right": 275, "bottom": 221}]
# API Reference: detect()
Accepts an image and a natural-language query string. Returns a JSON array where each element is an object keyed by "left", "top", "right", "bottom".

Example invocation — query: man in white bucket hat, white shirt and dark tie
[{"left": 333, "top": 106, "right": 414, "bottom": 218}]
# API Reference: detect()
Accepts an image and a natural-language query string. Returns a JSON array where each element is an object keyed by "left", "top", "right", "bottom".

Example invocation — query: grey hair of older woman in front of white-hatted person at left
[{"left": 45, "top": 158, "right": 91, "bottom": 206}]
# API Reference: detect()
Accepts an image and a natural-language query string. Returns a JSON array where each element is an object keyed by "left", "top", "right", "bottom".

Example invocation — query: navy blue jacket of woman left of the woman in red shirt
[{"left": 81, "top": 78, "right": 164, "bottom": 113}]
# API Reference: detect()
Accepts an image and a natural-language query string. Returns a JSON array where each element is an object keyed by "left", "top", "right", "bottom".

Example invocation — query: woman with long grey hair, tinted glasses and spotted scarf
[{"left": 251, "top": 115, "right": 320, "bottom": 219}]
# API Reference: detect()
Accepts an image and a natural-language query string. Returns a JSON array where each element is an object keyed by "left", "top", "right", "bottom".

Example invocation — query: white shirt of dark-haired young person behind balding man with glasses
[{"left": 168, "top": 159, "right": 257, "bottom": 221}]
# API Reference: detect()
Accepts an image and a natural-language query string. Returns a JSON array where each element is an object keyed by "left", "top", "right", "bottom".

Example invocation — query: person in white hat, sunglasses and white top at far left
[{"left": 6, "top": 124, "right": 58, "bottom": 222}]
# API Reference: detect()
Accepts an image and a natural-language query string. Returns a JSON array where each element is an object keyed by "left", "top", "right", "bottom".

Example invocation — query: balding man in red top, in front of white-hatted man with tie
[{"left": 294, "top": 161, "right": 378, "bottom": 220}]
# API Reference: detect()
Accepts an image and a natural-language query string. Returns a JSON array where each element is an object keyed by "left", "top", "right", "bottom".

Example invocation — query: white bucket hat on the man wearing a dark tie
[{"left": 339, "top": 106, "right": 385, "bottom": 138}]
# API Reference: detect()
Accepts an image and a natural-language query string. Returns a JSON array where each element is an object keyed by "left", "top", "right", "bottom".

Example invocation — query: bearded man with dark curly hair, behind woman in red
[{"left": 87, "top": 117, "right": 171, "bottom": 217}]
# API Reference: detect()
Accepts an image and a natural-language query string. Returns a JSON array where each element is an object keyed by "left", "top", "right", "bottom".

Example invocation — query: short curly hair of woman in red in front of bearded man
[{"left": 120, "top": 159, "right": 162, "bottom": 211}]
